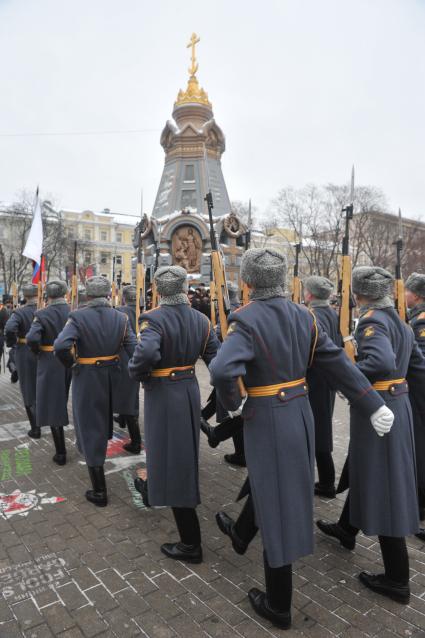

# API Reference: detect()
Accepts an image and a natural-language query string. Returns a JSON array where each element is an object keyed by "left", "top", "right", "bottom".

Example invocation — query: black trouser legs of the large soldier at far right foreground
[{"left": 338, "top": 494, "right": 409, "bottom": 585}]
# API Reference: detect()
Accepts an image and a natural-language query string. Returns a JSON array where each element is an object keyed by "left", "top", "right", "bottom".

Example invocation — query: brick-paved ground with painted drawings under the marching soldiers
[{"left": 0, "top": 364, "right": 425, "bottom": 638}]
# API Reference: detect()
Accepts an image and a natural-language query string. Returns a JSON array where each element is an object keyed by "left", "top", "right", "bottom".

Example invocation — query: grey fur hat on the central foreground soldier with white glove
[{"left": 241, "top": 248, "right": 286, "bottom": 289}]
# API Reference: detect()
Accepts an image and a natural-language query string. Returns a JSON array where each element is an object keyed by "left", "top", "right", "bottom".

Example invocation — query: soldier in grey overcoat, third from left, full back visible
[{"left": 53, "top": 277, "right": 136, "bottom": 507}]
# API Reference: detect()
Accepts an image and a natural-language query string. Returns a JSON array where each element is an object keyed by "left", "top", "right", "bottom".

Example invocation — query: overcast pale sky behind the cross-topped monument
[{"left": 0, "top": 0, "right": 425, "bottom": 217}]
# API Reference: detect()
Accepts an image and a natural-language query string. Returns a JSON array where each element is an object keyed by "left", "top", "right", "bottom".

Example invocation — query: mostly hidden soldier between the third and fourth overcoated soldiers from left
[{"left": 113, "top": 286, "right": 142, "bottom": 454}]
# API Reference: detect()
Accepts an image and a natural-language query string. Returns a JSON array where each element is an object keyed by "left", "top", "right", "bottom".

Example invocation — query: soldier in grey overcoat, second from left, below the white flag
[{"left": 26, "top": 279, "right": 71, "bottom": 465}]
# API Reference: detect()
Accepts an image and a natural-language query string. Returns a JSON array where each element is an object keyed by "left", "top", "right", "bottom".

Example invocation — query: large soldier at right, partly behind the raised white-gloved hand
[{"left": 317, "top": 266, "right": 425, "bottom": 604}]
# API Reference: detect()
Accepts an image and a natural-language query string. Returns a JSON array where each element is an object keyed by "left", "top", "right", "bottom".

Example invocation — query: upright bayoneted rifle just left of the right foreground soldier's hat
[{"left": 338, "top": 166, "right": 356, "bottom": 361}]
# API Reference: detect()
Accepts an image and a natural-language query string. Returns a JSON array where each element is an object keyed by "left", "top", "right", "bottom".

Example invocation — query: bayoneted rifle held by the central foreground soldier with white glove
[{"left": 204, "top": 149, "right": 246, "bottom": 399}]
